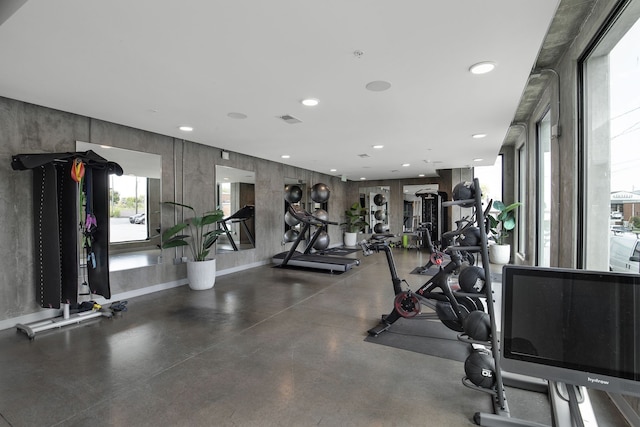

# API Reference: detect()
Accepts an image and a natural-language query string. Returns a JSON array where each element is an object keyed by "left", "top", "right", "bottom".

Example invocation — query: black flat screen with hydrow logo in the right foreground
[{"left": 500, "top": 265, "right": 640, "bottom": 396}]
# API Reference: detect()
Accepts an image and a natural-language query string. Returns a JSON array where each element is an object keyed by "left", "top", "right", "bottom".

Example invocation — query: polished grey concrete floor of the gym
[{"left": 0, "top": 249, "right": 624, "bottom": 427}]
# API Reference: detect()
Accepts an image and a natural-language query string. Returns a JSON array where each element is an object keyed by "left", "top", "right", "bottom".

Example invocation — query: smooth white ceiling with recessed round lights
[{"left": 0, "top": 0, "right": 558, "bottom": 180}]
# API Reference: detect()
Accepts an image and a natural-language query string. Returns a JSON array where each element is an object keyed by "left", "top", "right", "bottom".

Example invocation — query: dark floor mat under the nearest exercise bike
[{"left": 365, "top": 318, "right": 471, "bottom": 362}]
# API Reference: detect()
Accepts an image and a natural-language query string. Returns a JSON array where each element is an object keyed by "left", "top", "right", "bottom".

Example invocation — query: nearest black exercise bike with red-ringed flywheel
[{"left": 360, "top": 211, "right": 485, "bottom": 336}]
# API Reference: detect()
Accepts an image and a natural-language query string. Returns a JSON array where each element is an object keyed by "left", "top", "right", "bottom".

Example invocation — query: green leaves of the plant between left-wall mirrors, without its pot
[{"left": 162, "top": 202, "right": 224, "bottom": 261}]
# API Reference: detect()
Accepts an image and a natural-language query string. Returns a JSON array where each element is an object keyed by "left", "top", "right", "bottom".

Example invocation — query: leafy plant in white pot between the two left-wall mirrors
[{"left": 162, "top": 202, "right": 224, "bottom": 290}]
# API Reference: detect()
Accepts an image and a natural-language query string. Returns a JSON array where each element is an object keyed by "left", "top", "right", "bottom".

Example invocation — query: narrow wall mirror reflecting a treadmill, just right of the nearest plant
[{"left": 216, "top": 165, "right": 256, "bottom": 253}]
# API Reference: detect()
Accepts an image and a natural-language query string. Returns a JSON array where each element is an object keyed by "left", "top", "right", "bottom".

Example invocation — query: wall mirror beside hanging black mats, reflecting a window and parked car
[{"left": 76, "top": 141, "right": 162, "bottom": 271}]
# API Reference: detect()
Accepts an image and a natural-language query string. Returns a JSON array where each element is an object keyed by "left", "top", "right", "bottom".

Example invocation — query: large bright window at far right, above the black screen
[{"left": 580, "top": 1, "right": 640, "bottom": 273}]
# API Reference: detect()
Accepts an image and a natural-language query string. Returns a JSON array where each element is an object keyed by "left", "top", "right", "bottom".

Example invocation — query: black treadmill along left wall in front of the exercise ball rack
[{"left": 272, "top": 205, "right": 360, "bottom": 272}]
